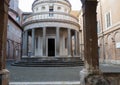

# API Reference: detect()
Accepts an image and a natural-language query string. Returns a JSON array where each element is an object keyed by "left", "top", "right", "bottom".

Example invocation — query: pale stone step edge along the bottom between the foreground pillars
[{"left": 9, "top": 81, "right": 80, "bottom": 85}]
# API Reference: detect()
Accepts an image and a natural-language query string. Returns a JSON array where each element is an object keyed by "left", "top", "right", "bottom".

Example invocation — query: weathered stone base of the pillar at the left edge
[{"left": 0, "top": 69, "right": 9, "bottom": 85}]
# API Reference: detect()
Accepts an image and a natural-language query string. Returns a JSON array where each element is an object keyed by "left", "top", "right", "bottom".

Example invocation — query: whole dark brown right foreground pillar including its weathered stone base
[{"left": 80, "top": 0, "right": 106, "bottom": 85}]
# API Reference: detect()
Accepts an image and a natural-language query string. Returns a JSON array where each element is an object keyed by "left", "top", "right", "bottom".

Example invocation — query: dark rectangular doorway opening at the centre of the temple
[{"left": 48, "top": 39, "right": 55, "bottom": 56}]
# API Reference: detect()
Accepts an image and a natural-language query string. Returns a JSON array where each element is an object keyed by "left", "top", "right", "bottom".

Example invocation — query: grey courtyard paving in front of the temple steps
[{"left": 7, "top": 61, "right": 120, "bottom": 82}]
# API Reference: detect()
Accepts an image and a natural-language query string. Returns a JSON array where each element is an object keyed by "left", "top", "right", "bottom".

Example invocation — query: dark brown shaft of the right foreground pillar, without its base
[{"left": 81, "top": 0, "right": 99, "bottom": 72}]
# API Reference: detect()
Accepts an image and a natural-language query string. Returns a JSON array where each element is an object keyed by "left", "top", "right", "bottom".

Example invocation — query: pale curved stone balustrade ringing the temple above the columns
[{"left": 23, "top": 12, "right": 78, "bottom": 24}]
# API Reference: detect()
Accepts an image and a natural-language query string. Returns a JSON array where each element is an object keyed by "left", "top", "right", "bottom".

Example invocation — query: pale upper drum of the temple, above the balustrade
[{"left": 32, "top": 0, "right": 71, "bottom": 13}]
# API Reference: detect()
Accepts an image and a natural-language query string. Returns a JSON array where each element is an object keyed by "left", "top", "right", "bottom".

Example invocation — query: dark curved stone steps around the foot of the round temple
[{"left": 12, "top": 58, "right": 84, "bottom": 67}]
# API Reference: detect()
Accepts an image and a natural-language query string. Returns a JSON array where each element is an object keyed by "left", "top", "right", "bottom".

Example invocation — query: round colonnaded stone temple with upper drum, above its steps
[{"left": 22, "top": 0, "right": 80, "bottom": 63}]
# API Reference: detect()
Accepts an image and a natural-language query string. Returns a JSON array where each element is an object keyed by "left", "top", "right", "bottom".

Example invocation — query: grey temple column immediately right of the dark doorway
[{"left": 56, "top": 27, "right": 60, "bottom": 57}]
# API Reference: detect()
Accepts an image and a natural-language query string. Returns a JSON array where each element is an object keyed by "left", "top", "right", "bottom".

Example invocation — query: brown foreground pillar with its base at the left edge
[{"left": 0, "top": 0, "right": 9, "bottom": 85}]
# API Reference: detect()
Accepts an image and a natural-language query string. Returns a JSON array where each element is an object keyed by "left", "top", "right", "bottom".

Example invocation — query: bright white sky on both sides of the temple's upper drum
[{"left": 19, "top": 0, "right": 81, "bottom": 12}]
